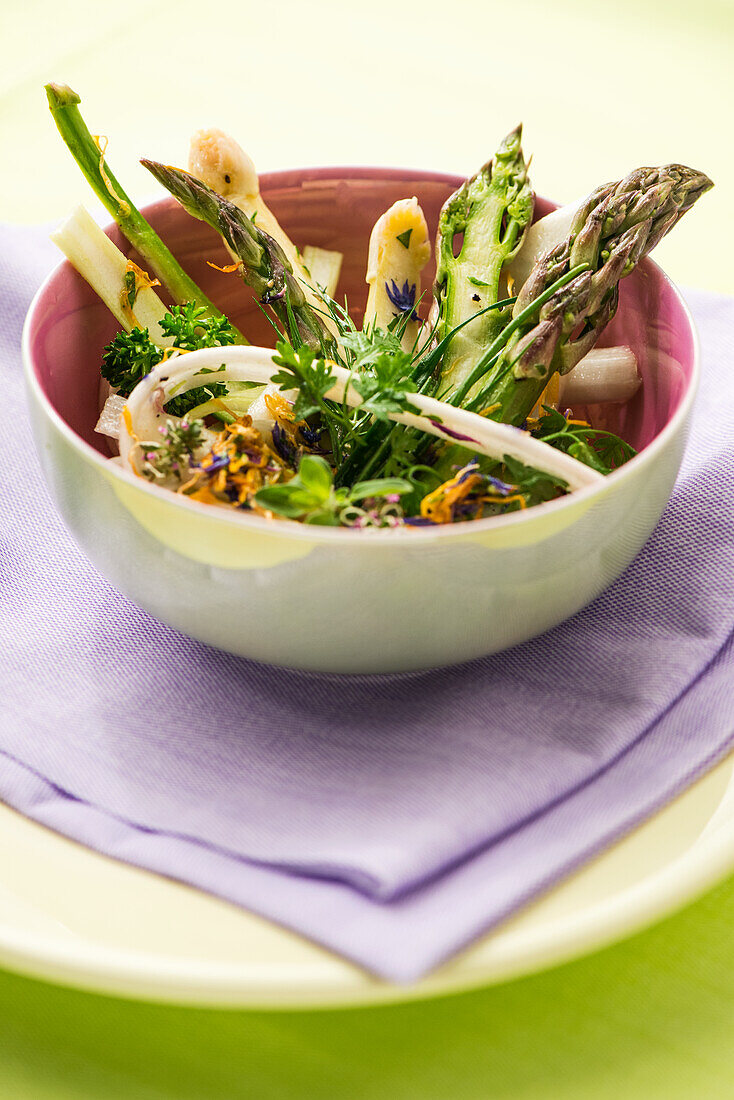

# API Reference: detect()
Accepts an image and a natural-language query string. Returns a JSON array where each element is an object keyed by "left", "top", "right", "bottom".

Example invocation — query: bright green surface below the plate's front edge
[{"left": 0, "top": 881, "right": 734, "bottom": 1100}]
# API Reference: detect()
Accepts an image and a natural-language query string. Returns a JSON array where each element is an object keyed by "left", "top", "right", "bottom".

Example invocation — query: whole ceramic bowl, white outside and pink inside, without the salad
[{"left": 23, "top": 168, "right": 698, "bottom": 673}]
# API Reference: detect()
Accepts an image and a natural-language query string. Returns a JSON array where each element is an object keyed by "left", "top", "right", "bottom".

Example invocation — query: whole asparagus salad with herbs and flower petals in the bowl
[{"left": 46, "top": 85, "right": 712, "bottom": 528}]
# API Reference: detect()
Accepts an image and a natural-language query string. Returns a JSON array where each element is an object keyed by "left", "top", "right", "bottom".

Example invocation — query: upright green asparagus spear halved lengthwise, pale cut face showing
[{"left": 435, "top": 127, "right": 535, "bottom": 399}]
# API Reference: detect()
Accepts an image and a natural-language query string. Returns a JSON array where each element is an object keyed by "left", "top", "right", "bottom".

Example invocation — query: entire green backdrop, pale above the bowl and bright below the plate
[{"left": 0, "top": 0, "right": 734, "bottom": 1100}]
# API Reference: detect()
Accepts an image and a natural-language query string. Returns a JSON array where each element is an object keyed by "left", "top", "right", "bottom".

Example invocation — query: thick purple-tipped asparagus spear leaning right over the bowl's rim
[{"left": 453, "top": 164, "right": 713, "bottom": 425}]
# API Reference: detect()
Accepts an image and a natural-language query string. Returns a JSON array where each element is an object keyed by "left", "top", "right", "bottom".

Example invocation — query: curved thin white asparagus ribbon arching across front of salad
[{"left": 120, "top": 345, "right": 604, "bottom": 490}]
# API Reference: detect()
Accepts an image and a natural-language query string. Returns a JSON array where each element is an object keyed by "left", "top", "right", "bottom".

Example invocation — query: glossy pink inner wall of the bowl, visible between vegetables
[{"left": 30, "top": 168, "right": 694, "bottom": 457}]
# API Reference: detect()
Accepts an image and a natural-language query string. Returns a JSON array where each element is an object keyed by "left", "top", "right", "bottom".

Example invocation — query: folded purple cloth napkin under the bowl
[{"left": 0, "top": 227, "right": 734, "bottom": 981}]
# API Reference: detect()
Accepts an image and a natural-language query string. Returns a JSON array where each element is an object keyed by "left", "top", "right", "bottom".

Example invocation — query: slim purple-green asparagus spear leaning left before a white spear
[{"left": 141, "top": 161, "right": 336, "bottom": 358}]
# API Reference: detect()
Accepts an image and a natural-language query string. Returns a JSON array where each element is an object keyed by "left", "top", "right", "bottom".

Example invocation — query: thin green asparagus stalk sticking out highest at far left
[{"left": 46, "top": 84, "right": 236, "bottom": 332}]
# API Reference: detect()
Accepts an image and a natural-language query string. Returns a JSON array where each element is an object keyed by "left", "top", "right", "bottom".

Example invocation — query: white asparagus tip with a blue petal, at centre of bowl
[{"left": 364, "top": 197, "right": 430, "bottom": 351}]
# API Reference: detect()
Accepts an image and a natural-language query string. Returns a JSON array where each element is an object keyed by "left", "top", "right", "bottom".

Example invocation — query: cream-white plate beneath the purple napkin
[{"left": 0, "top": 756, "right": 734, "bottom": 1008}]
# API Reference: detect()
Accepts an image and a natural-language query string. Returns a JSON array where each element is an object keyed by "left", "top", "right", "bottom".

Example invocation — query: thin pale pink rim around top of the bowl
[{"left": 21, "top": 173, "right": 701, "bottom": 547}]
